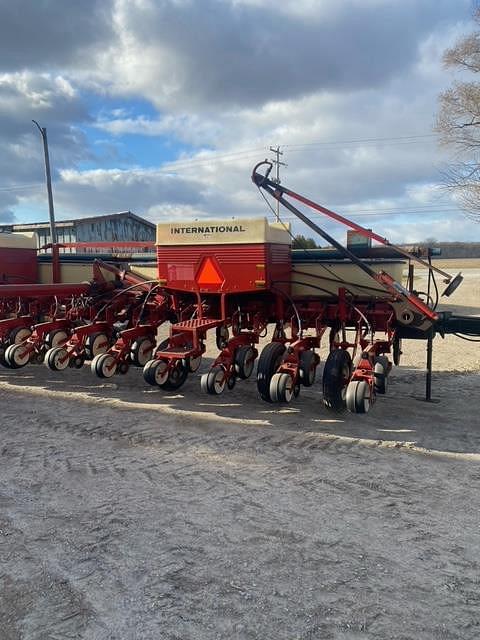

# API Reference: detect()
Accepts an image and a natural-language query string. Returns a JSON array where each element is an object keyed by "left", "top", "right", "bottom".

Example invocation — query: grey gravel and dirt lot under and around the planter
[{"left": 0, "top": 268, "right": 480, "bottom": 640}]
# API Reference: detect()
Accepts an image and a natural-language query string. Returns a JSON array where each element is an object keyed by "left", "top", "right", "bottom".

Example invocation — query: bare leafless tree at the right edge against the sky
[{"left": 435, "top": 9, "right": 480, "bottom": 221}]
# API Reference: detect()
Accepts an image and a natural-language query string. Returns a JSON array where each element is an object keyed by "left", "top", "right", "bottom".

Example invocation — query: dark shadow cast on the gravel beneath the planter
[{"left": 0, "top": 358, "right": 480, "bottom": 454}]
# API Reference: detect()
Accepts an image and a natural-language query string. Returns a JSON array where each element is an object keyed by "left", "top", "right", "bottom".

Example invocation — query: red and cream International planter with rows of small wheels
[{"left": 0, "top": 163, "right": 480, "bottom": 413}]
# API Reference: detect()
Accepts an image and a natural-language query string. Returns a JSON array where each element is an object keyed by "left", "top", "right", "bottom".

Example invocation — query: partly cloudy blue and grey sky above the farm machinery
[{"left": 0, "top": 0, "right": 480, "bottom": 242}]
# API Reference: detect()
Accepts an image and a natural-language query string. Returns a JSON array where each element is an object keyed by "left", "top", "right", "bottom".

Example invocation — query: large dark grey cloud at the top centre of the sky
[{"left": 100, "top": 0, "right": 468, "bottom": 111}]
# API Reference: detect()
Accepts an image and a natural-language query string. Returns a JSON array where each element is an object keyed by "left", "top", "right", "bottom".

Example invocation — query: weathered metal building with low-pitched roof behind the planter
[{"left": 0, "top": 211, "right": 156, "bottom": 249}]
